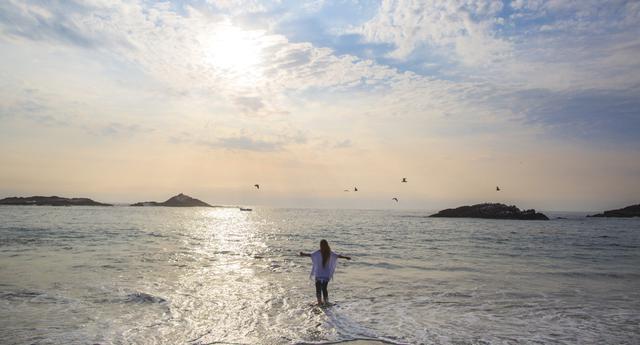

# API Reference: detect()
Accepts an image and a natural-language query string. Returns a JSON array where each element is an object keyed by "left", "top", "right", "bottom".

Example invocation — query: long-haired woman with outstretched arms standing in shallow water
[{"left": 300, "top": 240, "right": 351, "bottom": 305}]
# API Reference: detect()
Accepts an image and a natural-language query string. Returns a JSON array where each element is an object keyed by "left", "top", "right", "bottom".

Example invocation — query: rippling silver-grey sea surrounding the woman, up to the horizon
[{"left": 0, "top": 206, "right": 640, "bottom": 345}]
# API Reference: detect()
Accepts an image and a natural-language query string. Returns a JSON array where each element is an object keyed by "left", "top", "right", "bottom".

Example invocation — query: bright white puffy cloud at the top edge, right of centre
[{"left": 356, "top": 0, "right": 509, "bottom": 65}]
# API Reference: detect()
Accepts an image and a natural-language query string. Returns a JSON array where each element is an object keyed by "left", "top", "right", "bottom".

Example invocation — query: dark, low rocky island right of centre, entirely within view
[{"left": 429, "top": 203, "right": 549, "bottom": 220}]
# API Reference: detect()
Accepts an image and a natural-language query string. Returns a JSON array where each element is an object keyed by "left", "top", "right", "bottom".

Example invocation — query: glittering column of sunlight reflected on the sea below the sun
[{"left": 170, "top": 209, "right": 292, "bottom": 342}]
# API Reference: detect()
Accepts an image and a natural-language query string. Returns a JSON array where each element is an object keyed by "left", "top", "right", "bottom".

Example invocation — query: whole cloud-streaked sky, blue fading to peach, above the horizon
[{"left": 0, "top": 0, "right": 640, "bottom": 211}]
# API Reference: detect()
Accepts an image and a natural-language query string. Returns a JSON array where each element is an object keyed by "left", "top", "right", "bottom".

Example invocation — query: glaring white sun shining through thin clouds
[{"left": 205, "top": 25, "right": 262, "bottom": 82}]
